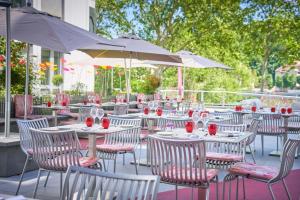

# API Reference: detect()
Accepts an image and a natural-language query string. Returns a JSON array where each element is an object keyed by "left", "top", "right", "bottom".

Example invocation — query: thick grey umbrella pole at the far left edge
[{"left": 4, "top": 7, "right": 11, "bottom": 137}]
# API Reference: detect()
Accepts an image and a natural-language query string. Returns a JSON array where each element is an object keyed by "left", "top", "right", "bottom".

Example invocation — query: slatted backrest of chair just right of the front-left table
[{"left": 104, "top": 127, "right": 141, "bottom": 147}]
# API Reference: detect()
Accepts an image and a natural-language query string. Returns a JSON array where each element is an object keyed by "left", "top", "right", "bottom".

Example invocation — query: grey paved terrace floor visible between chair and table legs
[{"left": 0, "top": 136, "right": 300, "bottom": 200}]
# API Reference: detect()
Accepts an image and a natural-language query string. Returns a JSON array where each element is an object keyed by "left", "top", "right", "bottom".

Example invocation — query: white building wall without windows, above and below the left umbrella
[{"left": 32, "top": 0, "right": 95, "bottom": 93}]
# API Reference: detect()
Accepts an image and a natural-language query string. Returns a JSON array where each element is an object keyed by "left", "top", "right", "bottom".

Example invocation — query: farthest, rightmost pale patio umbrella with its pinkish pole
[{"left": 144, "top": 51, "right": 231, "bottom": 95}]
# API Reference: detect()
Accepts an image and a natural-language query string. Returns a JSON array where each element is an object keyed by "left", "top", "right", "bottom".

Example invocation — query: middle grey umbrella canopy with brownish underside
[{"left": 80, "top": 35, "right": 181, "bottom": 63}]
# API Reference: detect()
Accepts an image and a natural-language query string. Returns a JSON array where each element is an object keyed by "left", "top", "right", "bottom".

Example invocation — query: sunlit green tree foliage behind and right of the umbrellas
[{"left": 96, "top": 0, "right": 300, "bottom": 95}]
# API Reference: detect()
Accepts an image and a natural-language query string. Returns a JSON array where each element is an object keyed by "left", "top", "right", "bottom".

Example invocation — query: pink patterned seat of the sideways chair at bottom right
[{"left": 228, "top": 162, "right": 278, "bottom": 180}]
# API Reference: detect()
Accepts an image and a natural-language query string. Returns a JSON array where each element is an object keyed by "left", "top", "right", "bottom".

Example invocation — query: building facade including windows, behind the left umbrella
[{"left": 13, "top": 0, "right": 96, "bottom": 94}]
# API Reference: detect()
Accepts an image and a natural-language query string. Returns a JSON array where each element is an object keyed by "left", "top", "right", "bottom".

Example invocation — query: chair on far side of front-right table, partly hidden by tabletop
[{"left": 206, "top": 124, "right": 247, "bottom": 169}]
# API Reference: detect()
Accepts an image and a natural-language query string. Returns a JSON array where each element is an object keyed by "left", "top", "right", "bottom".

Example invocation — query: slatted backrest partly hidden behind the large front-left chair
[{"left": 17, "top": 118, "right": 49, "bottom": 154}]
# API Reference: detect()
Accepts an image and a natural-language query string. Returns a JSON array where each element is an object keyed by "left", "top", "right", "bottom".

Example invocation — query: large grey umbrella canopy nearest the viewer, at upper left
[{"left": 0, "top": 7, "right": 114, "bottom": 53}]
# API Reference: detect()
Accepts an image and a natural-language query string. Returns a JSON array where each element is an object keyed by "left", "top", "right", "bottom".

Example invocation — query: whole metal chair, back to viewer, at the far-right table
[{"left": 254, "top": 113, "right": 285, "bottom": 155}]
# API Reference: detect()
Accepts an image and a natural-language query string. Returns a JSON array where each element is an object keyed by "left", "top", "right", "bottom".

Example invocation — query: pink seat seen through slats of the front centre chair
[{"left": 161, "top": 167, "right": 219, "bottom": 184}]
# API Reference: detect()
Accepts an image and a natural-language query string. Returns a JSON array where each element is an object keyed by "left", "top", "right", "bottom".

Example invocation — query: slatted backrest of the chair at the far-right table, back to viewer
[{"left": 255, "top": 113, "right": 284, "bottom": 135}]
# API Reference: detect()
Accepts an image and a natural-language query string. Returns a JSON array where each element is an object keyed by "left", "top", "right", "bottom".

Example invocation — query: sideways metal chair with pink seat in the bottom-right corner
[{"left": 223, "top": 138, "right": 300, "bottom": 200}]
